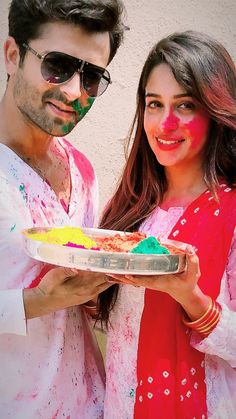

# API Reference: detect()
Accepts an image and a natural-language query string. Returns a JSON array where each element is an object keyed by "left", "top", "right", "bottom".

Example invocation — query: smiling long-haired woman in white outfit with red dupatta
[{"left": 100, "top": 31, "right": 236, "bottom": 419}]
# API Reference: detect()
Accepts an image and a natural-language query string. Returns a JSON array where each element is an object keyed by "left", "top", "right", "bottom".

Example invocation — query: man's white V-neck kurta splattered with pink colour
[{"left": 0, "top": 140, "right": 104, "bottom": 419}]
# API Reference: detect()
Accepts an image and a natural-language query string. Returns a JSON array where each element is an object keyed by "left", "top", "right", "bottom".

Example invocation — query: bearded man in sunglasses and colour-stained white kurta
[{"left": 0, "top": 0, "right": 123, "bottom": 419}]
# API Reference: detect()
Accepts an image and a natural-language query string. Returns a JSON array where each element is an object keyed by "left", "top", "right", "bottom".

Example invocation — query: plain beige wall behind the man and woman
[{"left": 0, "top": 0, "right": 236, "bottom": 217}]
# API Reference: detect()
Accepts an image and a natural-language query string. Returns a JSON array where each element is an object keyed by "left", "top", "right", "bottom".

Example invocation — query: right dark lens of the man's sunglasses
[{"left": 82, "top": 65, "right": 110, "bottom": 97}]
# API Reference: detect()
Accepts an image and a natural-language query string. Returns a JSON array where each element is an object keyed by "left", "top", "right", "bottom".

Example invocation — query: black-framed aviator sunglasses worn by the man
[{"left": 22, "top": 43, "right": 111, "bottom": 97}]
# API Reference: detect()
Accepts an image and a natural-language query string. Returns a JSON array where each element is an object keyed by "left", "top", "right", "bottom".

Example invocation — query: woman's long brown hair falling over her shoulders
[{"left": 99, "top": 31, "right": 236, "bottom": 326}]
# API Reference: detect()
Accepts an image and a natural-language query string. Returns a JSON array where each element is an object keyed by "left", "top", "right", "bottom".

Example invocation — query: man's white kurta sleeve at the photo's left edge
[{"left": 0, "top": 175, "right": 26, "bottom": 335}]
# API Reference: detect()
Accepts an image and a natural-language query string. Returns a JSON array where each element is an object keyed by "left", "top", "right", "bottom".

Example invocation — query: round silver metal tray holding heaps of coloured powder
[{"left": 22, "top": 228, "right": 187, "bottom": 275}]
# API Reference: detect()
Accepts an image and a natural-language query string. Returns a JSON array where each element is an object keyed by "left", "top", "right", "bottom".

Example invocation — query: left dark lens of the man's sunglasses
[{"left": 41, "top": 52, "right": 75, "bottom": 84}]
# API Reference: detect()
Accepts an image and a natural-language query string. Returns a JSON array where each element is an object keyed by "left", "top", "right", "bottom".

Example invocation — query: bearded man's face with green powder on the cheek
[{"left": 13, "top": 22, "right": 110, "bottom": 137}]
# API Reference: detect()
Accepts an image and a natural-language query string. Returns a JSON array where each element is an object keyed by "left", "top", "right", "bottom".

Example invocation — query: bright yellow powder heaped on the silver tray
[{"left": 27, "top": 227, "right": 97, "bottom": 249}]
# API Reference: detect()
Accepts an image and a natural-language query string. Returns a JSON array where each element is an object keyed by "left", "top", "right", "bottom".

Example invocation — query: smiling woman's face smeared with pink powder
[{"left": 144, "top": 63, "right": 210, "bottom": 167}]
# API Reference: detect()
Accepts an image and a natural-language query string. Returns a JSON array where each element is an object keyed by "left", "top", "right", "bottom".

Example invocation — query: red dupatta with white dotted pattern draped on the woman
[{"left": 134, "top": 185, "right": 236, "bottom": 419}]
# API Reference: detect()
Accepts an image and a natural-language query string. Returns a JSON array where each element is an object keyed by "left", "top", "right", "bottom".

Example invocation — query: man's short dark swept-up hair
[{"left": 8, "top": 0, "right": 125, "bottom": 62}]
